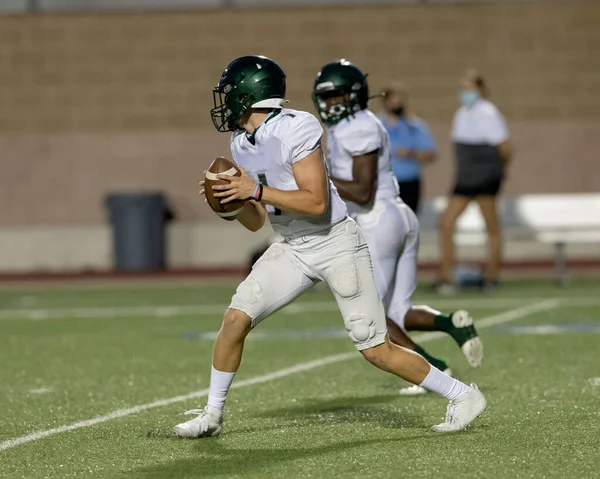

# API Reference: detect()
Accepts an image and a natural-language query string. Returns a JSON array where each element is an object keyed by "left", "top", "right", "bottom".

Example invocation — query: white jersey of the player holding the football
[{"left": 231, "top": 108, "right": 348, "bottom": 238}]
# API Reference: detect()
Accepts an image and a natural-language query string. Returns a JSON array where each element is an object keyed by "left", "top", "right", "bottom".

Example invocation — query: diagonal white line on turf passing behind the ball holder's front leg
[{"left": 0, "top": 299, "right": 561, "bottom": 451}]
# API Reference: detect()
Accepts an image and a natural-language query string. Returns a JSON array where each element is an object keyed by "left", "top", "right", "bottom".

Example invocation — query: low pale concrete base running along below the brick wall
[{"left": 5, "top": 221, "right": 600, "bottom": 273}]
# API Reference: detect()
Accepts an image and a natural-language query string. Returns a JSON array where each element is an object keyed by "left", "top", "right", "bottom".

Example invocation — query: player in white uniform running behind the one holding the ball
[{"left": 312, "top": 60, "right": 483, "bottom": 394}]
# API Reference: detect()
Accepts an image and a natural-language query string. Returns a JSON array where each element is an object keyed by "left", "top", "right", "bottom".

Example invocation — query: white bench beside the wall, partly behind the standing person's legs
[{"left": 419, "top": 193, "right": 600, "bottom": 284}]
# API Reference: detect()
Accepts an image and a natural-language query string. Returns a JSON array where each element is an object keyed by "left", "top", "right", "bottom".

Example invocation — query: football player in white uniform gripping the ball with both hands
[{"left": 175, "top": 56, "right": 486, "bottom": 438}]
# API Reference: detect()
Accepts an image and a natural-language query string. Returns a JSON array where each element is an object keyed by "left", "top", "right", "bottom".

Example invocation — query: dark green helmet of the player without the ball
[{"left": 312, "top": 59, "right": 369, "bottom": 125}]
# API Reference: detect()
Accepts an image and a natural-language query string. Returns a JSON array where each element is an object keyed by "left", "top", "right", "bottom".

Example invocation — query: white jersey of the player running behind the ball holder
[{"left": 327, "top": 110, "right": 399, "bottom": 217}]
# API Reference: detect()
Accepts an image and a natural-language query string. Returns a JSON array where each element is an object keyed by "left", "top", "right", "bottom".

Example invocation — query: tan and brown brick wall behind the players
[{"left": 0, "top": 0, "right": 600, "bottom": 226}]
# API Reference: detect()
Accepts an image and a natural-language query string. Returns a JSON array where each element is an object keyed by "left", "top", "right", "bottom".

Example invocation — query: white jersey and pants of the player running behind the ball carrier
[{"left": 327, "top": 110, "right": 419, "bottom": 329}]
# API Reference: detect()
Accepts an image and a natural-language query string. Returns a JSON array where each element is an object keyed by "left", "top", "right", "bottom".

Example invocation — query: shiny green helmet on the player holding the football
[{"left": 210, "top": 55, "right": 286, "bottom": 132}]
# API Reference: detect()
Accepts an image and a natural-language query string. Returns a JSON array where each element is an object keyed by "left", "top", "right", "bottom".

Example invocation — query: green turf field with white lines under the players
[{"left": 0, "top": 280, "right": 600, "bottom": 478}]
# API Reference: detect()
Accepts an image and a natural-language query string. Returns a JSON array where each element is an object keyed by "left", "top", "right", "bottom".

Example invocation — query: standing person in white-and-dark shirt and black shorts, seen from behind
[{"left": 437, "top": 70, "right": 512, "bottom": 294}]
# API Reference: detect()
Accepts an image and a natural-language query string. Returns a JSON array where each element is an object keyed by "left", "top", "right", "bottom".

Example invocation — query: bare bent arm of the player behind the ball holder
[{"left": 331, "top": 151, "right": 378, "bottom": 205}]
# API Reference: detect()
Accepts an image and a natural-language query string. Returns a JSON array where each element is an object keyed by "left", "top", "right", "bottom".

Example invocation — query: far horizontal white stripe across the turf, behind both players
[{"left": 0, "top": 297, "right": 600, "bottom": 320}]
